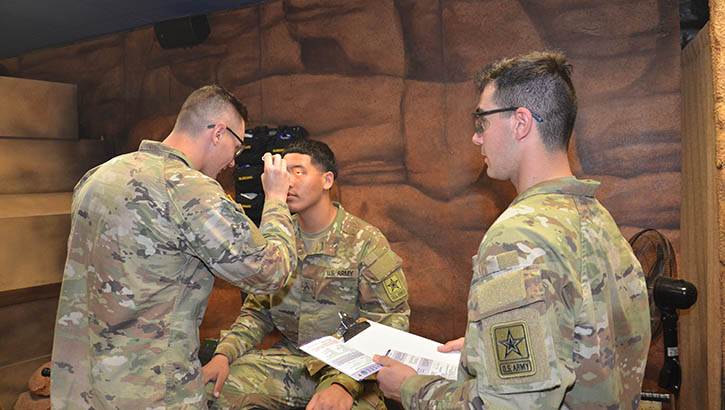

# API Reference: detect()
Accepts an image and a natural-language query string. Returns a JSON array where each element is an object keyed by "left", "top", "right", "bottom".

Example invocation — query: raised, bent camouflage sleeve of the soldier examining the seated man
[{"left": 167, "top": 173, "right": 297, "bottom": 294}]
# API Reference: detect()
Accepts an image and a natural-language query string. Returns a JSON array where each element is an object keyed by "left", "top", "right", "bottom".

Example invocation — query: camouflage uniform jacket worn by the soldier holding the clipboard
[{"left": 401, "top": 177, "right": 650, "bottom": 409}]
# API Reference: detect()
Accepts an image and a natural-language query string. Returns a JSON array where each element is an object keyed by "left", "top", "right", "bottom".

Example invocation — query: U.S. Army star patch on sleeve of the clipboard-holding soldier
[{"left": 491, "top": 320, "right": 536, "bottom": 379}]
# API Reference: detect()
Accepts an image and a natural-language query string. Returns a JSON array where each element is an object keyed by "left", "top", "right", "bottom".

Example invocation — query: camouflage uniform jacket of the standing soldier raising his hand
[{"left": 51, "top": 141, "right": 297, "bottom": 410}]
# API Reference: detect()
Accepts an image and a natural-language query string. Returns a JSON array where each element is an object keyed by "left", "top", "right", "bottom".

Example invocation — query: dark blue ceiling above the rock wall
[{"left": 0, "top": 0, "right": 263, "bottom": 58}]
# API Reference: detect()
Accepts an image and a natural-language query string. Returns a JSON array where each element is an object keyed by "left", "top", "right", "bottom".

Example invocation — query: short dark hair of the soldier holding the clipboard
[{"left": 474, "top": 51, "right": 577, "bottom": 151}]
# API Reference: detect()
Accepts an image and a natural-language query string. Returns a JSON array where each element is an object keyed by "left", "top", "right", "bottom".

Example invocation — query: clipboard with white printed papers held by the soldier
[{"left": 300, "top": 312, "right": 460, "bottom": 381}]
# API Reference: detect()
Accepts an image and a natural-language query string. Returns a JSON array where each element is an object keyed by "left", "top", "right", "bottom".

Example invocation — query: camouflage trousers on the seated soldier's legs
[{"left": 206, "top": 346, "right": 385, "bottom": 410}]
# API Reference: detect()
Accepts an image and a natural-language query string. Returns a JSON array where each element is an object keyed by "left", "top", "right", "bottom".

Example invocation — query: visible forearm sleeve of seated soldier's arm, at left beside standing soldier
[{"left": 214, "top": 295, "right": 274, "bottom": 363}]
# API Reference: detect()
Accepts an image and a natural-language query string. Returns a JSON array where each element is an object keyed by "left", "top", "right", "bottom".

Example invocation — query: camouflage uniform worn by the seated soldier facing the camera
[{"left": 210, "top": 202, "right": 410, "bottom": 409}]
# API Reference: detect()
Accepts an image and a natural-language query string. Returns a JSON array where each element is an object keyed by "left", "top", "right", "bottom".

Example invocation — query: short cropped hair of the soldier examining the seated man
[{"left": 175, "top": 85, "right": 249, "bottom": 132}]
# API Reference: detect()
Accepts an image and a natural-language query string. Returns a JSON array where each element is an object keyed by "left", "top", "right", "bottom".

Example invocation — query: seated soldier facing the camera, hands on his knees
[{"left": 204, "top": 140, "right": 410, "bottom": 410}]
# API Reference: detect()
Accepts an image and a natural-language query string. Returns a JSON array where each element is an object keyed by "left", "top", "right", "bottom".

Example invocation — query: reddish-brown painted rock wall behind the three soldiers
[{"left": 0, "top": 0, "right": 681, "bottom": 394}]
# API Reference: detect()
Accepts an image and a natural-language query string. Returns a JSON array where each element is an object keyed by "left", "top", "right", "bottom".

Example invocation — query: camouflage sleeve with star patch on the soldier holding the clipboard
[{"left": 401, "top": 226, "right": 574, "bottom": 409}]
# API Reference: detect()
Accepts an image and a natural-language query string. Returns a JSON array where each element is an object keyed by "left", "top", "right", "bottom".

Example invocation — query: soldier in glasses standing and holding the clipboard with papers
[{"left": 375, "top": 53, "right": 650, "bottom": 409}]
